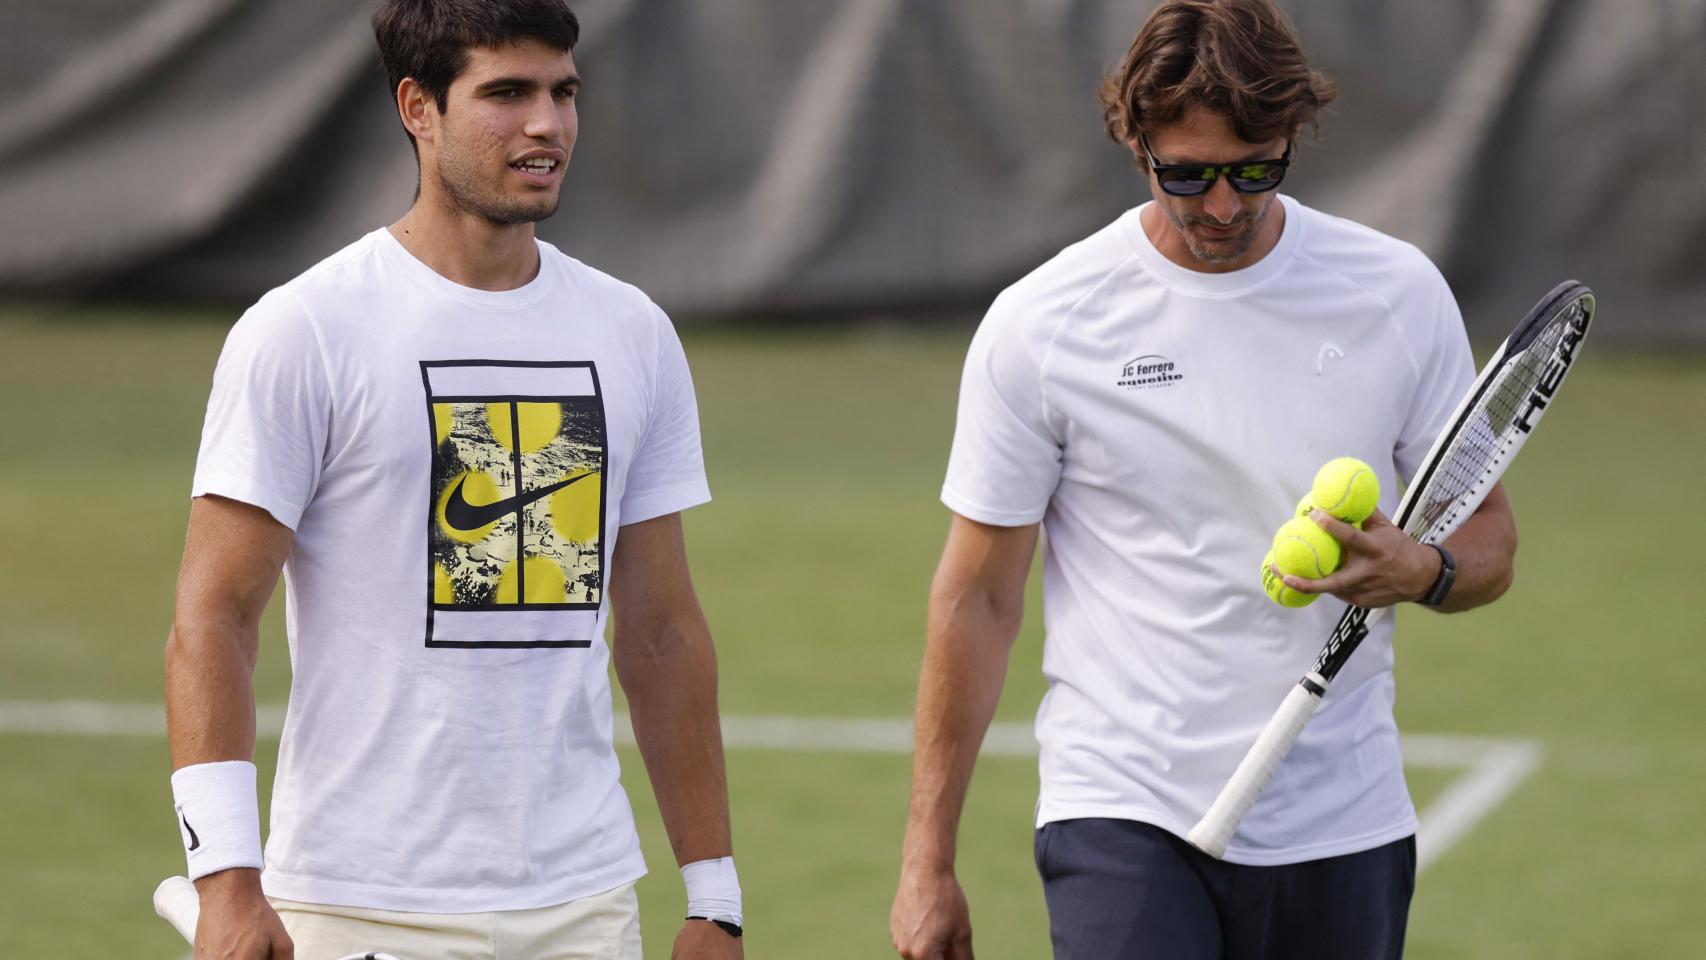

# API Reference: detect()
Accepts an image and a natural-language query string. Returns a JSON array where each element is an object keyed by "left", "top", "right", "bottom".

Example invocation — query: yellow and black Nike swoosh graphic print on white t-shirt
[{"left": 423, "top": 361, "right": 606, "bottom": 643}]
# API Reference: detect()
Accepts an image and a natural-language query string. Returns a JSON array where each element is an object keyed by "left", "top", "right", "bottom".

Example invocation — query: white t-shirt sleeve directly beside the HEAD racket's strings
[{"left": 1392, "top": 264, "right": 1476, "bottom": 481}]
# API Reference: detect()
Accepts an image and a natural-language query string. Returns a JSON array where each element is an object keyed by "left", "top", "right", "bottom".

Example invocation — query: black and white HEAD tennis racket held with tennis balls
[{"left": 1187, "top": 280, "right": 1595, "bottom": 859}]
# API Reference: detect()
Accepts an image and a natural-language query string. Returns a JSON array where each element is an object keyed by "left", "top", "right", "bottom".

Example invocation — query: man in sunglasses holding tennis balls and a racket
[{"left": 891, "top": 0, "right": 1517, "bottom": 960}]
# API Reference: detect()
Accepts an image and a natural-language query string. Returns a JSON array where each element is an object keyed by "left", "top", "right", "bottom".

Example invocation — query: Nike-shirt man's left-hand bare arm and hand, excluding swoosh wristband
[{"left": 165, "top": 496, "right": 292, "bottom": 958}]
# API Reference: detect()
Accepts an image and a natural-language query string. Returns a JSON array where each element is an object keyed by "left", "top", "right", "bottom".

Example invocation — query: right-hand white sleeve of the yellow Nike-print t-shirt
[{"left": 621, "top": 314, "right": 711, "bottom": 523}]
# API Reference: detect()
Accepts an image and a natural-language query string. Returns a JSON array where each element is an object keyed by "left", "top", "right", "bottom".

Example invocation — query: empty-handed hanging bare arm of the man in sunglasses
[{"left": 889, "top": 517, "right": 1037, "bottom": 960}]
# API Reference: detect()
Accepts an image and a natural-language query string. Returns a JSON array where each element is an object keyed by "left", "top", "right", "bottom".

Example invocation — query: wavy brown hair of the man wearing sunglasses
[{"left": 1100, "top": 0, "right": 1338, "bottom": 167}]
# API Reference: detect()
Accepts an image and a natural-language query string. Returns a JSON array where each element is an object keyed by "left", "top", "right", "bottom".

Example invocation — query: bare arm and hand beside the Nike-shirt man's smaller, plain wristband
[{"left": 611, "top": 513, "right": 740, "bottom": 958}]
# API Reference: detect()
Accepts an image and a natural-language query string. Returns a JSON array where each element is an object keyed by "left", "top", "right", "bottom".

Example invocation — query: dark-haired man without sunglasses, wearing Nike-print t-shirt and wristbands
[{"left": 165, "top": 0, "right": 742, "bottom": 960}]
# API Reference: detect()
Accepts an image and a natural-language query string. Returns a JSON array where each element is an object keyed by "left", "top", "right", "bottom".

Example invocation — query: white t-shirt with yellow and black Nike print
[{"left": 193, "top": 230, "right": 710, "bottom": 912}]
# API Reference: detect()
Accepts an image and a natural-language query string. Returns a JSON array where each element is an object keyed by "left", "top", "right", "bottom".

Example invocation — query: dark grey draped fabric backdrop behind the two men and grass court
[{"left": 0, "top": 0, "right": 1706, "bottom": 343}]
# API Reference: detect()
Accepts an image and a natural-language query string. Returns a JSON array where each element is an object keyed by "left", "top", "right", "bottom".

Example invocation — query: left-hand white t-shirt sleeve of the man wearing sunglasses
[{"left": 942, "top": 295, "right": 1063, "bottom": 527}]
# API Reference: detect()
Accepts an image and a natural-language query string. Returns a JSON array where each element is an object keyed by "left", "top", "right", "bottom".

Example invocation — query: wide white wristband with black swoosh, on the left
[{"left": 172, "top": 760, "right": 263, "bottom": 880}]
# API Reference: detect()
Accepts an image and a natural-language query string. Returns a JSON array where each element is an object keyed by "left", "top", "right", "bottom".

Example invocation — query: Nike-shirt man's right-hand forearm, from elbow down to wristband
[{"left": 612, "top": 619, "right": 732, "bottom": 865}]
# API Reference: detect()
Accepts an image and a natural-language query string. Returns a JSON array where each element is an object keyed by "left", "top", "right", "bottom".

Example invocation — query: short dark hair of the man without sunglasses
[{"left": 374, "top": 0, "right": 580, "bottom": 142}]
